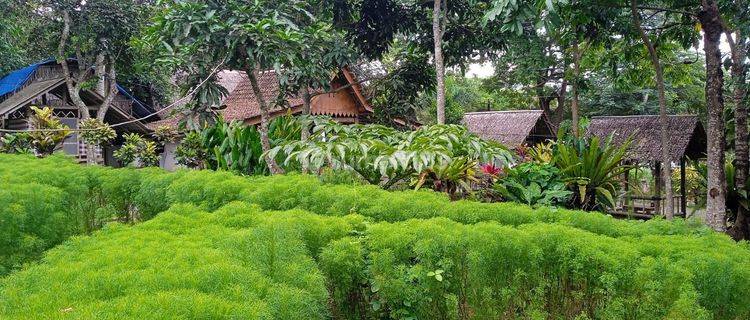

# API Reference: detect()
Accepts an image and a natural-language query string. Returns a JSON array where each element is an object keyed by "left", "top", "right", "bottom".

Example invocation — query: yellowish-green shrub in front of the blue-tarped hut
[{"left": 29, "top": 106, "right": 71, "bottom": 157}]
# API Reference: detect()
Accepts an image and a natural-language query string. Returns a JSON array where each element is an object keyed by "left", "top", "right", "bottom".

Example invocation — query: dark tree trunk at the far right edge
[{"left": 725, "top": 30, "right": 750, "bottom": 240}]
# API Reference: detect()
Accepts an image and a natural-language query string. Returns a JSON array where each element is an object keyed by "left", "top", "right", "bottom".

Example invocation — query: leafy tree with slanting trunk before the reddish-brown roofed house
[{"left": 153, "top": 0, "right": 352, "bottom": 174}]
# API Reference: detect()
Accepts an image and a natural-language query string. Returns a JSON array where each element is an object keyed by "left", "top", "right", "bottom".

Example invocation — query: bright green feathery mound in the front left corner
[{"left": 0, "top": 206, "right": 334, "bottom": 319}]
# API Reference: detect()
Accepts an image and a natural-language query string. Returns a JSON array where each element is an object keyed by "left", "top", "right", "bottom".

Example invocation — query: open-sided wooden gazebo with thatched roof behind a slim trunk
[{"left": 587, "top": 115, "right": 706, "bottom": 218}]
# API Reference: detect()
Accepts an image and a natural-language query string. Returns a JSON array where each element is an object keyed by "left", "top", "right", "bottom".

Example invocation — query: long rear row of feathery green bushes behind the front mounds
[{"left": 0, "top": 155, "right": 707, "bottom": 275}]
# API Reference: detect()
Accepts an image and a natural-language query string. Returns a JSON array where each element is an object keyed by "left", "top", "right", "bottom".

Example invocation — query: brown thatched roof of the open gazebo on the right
[{"left": 588, "top": 115, "right": 706, "bottom": 162}]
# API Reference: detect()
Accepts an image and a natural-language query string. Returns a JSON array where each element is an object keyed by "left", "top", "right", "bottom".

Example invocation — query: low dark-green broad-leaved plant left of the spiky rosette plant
[{"left": 495, "top": 162, "right": 572, "bottom": 206}]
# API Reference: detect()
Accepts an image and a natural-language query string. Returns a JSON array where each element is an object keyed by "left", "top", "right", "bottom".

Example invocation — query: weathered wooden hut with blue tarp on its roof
[{"left": 0, "top": 59, "right": 154, "bottom": 163}]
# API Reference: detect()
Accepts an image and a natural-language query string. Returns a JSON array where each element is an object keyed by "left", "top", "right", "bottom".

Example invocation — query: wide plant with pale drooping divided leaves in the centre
[{"left": 270, "top": 119, "right": 511, "bottom": 194}]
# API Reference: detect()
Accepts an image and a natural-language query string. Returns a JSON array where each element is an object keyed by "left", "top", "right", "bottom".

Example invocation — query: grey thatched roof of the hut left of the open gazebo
[{"left": 463, "top": 110, "right": 555, "bottom": 147}]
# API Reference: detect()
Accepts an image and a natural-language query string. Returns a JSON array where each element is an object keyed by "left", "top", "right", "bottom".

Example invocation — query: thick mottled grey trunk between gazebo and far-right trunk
[{"left": 698, "top": 0, "right": 726, "bottom": 232}]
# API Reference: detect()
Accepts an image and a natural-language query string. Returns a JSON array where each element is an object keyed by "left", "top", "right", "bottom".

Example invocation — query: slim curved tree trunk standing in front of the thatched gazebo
[{"left": 630, "top": 0, "right": 674, "bottom": 220}]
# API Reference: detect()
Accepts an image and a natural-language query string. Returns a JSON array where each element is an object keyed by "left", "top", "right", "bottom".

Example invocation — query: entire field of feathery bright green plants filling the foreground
[{"left": 0, "top": 155, "right": 750, "bottom": 319}]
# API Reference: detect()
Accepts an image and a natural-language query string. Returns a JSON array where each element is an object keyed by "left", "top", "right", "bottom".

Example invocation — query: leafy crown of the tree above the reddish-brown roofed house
[{"left": 152, "top": 0, "right": 352, "bottom": 129}]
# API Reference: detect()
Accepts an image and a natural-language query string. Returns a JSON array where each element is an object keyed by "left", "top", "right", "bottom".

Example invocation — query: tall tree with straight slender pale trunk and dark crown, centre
[{"left": 340, "top": 0, "right": 507, "bottom": 122}]
